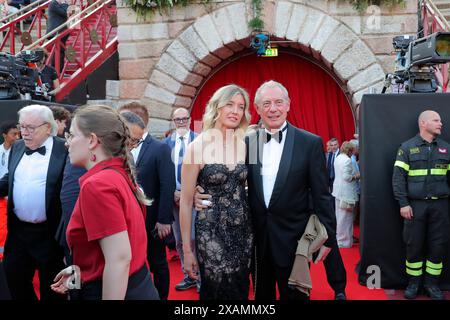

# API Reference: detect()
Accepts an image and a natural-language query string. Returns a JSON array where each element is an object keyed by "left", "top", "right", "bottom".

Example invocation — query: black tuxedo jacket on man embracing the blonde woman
[{"left": 246, "top": 124, "right": 336, "bottom": 267}]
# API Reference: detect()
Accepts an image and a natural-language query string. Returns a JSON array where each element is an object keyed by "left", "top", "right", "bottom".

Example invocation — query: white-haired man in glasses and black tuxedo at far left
[{"left": 0, "top": 105, "right": 67, "bottom": 300}]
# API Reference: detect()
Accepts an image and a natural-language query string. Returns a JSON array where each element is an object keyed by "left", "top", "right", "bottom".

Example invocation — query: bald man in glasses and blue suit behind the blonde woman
[{"left": 164, "top": 108, "right": 197, "bottom": 291}]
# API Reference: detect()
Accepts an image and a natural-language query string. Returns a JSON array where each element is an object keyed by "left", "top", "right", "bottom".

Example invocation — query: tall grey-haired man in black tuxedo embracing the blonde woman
[{"left": 195, "top": 80, "right": 336, "bottom": 300}]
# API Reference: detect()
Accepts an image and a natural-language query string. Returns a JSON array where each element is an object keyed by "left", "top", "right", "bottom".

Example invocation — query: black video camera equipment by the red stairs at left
[{"left": 0, "top": 50, "right": 46, "bottom": 100}]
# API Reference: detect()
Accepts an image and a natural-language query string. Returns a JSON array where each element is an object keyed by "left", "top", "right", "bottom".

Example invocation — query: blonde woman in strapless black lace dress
[{"left": 180, "top": 85, "right": 253, "bottom": 300}]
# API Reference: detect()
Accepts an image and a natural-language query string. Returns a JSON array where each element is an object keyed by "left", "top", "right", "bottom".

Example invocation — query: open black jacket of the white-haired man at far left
[{"left": 0, "top": 137, "right": 67, "bottom": 235}]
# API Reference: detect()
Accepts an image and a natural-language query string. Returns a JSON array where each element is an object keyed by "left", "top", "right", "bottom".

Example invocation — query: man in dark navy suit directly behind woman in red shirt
[{"left": 119, "top": 102, "right": 175, "bottom": 300}]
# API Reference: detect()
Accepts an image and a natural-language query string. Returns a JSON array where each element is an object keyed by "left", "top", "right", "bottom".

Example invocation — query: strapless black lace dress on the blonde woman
[{"left": 195, "top": 164, "right": 253, "bottom": 300}]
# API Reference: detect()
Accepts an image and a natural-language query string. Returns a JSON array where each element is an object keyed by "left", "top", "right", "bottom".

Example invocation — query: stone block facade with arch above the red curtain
[{"left": 111, "top": 0, "right": 417, "bottom": 136}]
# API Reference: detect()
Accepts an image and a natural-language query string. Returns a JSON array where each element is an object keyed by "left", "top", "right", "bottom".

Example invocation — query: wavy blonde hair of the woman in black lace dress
[{"left": 203, "top": 84, "right": 251, "bottom": 133}]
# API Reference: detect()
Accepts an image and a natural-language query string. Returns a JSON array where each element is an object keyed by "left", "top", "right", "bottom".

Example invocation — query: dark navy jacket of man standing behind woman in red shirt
[{"left": 136, "top": 134, "right": 175, "bottom": 231}]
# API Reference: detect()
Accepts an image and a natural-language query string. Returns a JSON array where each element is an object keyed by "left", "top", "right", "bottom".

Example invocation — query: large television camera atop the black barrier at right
[{"left": 382, "top": 32, "right": 450, "bottom": 93}]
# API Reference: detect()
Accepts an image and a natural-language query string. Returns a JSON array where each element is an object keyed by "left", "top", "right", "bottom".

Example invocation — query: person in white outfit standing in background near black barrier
[{"left": 332, "top": 141, "right": 359, "bottom": 248}]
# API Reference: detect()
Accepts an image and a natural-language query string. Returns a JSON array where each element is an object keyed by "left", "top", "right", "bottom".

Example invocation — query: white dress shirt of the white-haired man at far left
[{"left": 13, "top": 137, "right": 53, "bottom": 223}]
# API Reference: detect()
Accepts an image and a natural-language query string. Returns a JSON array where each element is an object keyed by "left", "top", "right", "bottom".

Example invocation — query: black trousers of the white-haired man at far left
[{"left": 3, "top": 220, "right": 65, "bottom": 300}]
